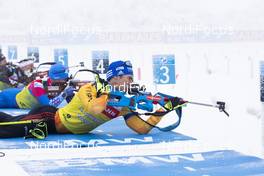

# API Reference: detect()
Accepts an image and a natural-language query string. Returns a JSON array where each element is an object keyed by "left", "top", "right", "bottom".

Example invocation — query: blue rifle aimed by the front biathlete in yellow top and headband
[{"left": 108, "top": 91, "right": 229, "bottom": 131}]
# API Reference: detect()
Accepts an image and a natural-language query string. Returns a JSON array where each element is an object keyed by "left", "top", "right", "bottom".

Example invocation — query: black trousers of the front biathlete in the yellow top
[{"left": 0, "top": 106, "right": 57, "bottom": 138}]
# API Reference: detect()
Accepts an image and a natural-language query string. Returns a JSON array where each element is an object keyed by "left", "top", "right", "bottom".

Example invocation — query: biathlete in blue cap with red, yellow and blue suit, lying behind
[{"left": 0, "top": 64, "right": 74, "bottom": 109}]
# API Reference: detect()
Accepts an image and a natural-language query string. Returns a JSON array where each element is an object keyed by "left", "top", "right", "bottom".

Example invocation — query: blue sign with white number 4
[{"left": 92, "top": 51, "right": 109, "bottom": 74}]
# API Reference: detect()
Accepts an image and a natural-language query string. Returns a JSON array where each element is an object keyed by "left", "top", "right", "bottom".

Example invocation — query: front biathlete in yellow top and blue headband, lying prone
[{"left": 0, "top": 61, "right": 180, "bottom": 137}]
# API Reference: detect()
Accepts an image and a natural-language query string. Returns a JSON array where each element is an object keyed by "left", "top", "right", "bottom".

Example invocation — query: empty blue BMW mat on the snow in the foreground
[{"left": 17, "top": 150, "right": 264, "bottom": 176}]
